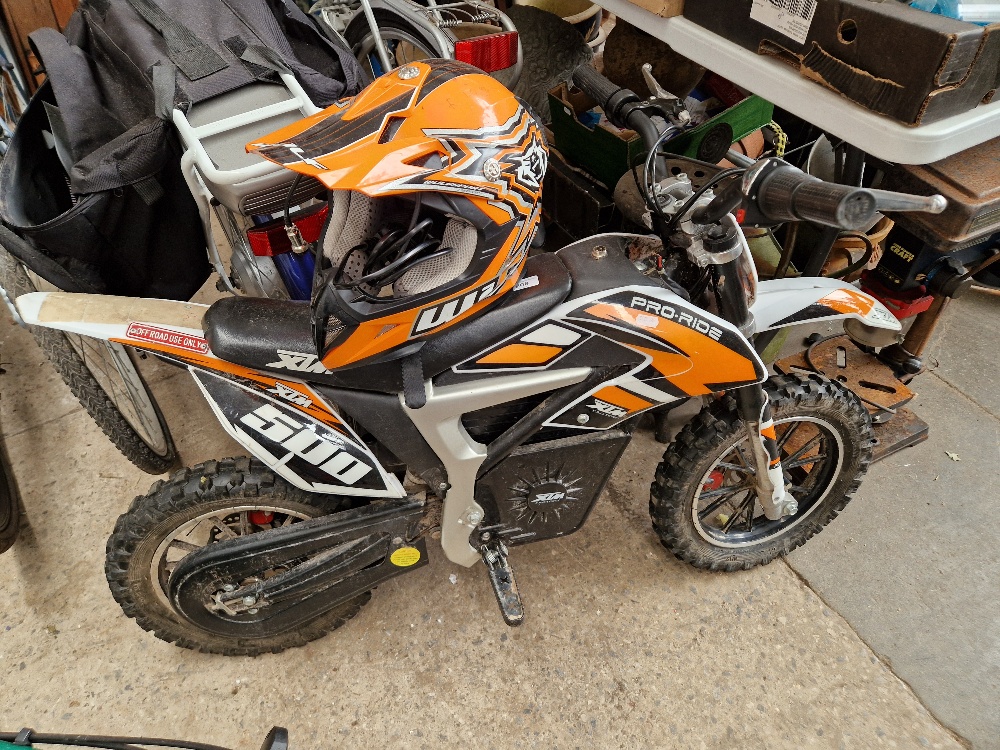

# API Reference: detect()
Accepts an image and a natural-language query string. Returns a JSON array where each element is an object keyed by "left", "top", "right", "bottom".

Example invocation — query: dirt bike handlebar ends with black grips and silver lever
[{"left": 573, "top": 65, "right": 948, "bottom": 230}]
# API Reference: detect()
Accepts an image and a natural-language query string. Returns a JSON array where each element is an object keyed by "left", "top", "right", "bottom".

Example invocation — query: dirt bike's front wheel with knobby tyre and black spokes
[{"left": 649, "top": 375, "right": 875, "bottom": 571}]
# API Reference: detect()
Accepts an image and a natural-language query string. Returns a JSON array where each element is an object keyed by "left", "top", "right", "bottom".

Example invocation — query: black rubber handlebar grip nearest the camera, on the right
[{"left": 756, "top": 167, "right": 878, "bottom": 229}]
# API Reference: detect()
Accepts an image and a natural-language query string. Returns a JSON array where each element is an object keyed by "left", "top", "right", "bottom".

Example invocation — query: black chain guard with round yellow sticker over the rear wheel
[{"left": 167, "top": 500, "right": 427, "bottom": 638}]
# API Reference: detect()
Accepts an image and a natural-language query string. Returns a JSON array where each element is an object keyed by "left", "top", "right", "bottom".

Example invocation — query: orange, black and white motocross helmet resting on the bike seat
[{"left": 247, "top": 60, "right": 548, "bottom": 369}]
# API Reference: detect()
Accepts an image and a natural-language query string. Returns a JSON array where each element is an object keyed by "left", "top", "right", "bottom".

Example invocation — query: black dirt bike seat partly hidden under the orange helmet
[{"left": 202, "top": 254, "right": 572, "bottom": 393}]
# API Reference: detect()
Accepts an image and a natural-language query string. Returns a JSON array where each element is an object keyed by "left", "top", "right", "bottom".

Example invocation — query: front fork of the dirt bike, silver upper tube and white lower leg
[{"left": 705, "top": 225, "right": 799, "bottom": 521}]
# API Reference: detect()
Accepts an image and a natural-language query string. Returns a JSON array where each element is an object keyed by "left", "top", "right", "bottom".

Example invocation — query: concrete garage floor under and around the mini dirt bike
[{"left": 0, "top": 288, "right": 988, "bottom": 748}]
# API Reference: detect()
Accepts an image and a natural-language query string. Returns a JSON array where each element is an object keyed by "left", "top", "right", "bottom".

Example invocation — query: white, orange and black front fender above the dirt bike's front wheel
[{"left": 750, "top": 277, "right": 901, "bottom": 333}]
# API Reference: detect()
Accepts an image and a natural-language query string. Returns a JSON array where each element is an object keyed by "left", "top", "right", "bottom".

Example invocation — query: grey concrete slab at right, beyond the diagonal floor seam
[{"left": 789, "top": 293, "right": 1000, "bottom": 750}]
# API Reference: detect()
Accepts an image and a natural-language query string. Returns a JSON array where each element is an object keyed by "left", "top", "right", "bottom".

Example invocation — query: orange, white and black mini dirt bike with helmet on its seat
[{"left": 17, "top": 60, "right": 939, "bottom": 654}]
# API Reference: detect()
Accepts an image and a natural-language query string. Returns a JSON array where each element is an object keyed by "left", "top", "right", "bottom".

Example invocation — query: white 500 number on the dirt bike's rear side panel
[{"left": 240, "top": 404, "right": 372, "bottom": 485}]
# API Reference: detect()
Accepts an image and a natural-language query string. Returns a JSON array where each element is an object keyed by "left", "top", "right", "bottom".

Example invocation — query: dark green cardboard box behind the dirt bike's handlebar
[{"left": 549, "top": 85, "right": 774, "bottom": 190}]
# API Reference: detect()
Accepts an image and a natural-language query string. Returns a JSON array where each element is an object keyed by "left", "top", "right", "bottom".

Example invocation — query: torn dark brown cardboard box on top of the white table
[{"left": 684, "top": 0, "right": 1000, "bottom": 125}]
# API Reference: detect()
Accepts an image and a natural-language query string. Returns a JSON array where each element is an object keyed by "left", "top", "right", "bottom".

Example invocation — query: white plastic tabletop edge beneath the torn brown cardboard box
[{"left": 594, "top": 0, "right": 1000, "bottom": 164}]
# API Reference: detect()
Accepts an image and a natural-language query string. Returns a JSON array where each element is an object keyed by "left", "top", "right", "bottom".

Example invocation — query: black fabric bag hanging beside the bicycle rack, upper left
[{"left": 0, "top": 0, "right": 362, "bottom": 299}]
